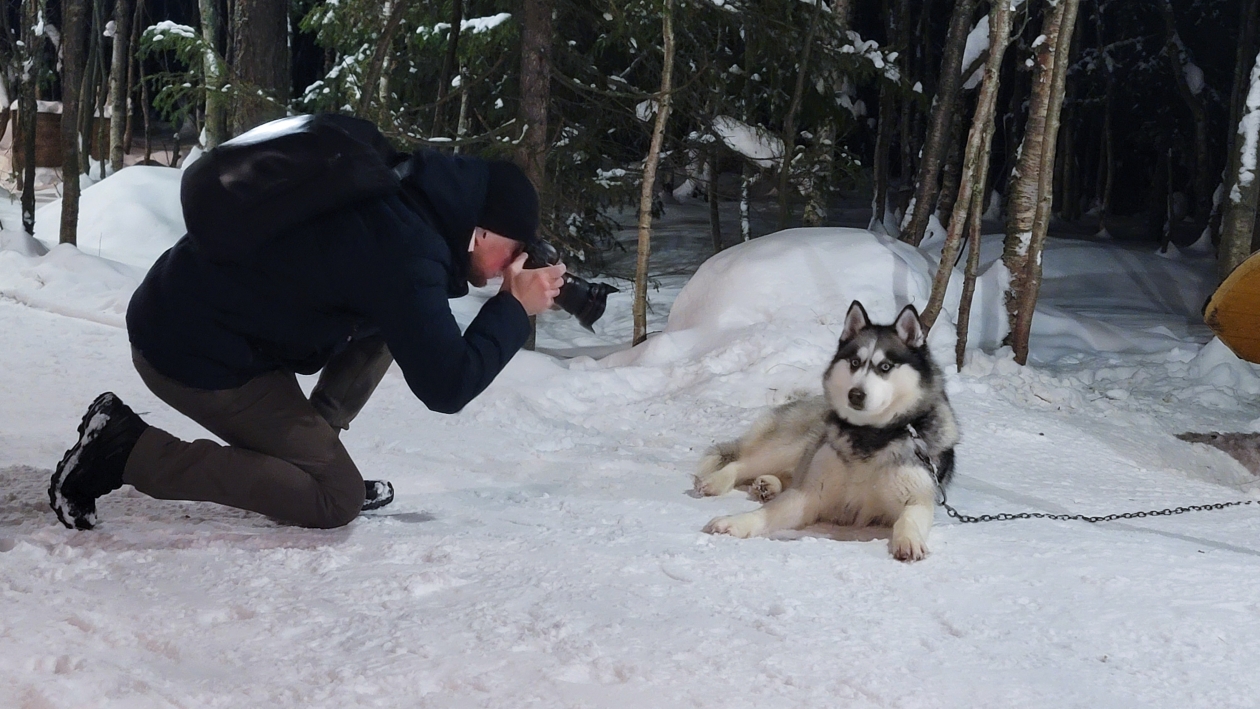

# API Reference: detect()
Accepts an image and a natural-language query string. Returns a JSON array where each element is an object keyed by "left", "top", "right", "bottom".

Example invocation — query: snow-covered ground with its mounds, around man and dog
[{"left": 0, "top": 167, "right": 1260, "bottom": 709}]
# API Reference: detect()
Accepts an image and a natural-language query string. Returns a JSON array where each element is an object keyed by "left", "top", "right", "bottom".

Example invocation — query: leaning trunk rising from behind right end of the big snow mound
[{"left": 901, "top": 0, "right": 975, "bottom": 246}]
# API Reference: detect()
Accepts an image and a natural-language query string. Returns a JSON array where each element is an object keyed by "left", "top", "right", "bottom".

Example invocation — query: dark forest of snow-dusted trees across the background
[{"left": 0, "top": 0, "right": 1260, "bottom": 363}]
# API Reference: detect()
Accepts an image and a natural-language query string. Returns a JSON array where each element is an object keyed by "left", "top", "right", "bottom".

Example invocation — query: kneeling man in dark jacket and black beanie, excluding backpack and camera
[{"left": 49, "top": 124, "right": 564, "bottom": 529}]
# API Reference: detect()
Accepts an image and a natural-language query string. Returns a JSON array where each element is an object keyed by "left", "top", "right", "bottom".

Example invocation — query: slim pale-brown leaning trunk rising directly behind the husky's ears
[{"left": 920, "top": 1, "right": 1012, "bottom": 329}]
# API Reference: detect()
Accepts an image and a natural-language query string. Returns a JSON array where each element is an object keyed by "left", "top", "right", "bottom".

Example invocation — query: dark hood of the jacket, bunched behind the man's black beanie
[{"left": 398, "top": 150, "right": 489, "bottom": 295}]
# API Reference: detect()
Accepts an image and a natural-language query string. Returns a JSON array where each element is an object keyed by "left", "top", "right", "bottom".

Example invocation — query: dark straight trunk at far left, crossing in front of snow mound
[{"left": 60, "top": 0, "right": 88, "bottom": 244}]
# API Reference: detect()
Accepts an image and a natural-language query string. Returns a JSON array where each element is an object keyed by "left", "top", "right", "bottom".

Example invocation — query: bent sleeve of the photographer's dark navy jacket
[{"left": 332, "top": 207, "right": 529, "bottom": 413}]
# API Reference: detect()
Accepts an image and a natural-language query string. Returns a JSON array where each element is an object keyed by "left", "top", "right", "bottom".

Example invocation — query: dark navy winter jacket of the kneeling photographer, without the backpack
[{"left": 127, "top": 152, "right": 529, "bottom": 413}]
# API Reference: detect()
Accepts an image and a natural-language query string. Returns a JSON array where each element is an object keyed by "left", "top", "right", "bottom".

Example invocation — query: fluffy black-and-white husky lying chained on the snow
[{"left": 696, "top": 301, "right": 959, "bottom": 562}]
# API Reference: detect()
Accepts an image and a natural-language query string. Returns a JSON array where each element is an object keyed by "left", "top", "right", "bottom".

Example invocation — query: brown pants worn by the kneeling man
[{"left": 122, "top": 337, "right": 392, "bottom": 529}]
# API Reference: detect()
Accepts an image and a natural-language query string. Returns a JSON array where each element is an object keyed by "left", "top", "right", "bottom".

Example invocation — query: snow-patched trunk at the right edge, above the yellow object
[{"left": 1217, "top": 47, "right": 1260, "bottom": 280}]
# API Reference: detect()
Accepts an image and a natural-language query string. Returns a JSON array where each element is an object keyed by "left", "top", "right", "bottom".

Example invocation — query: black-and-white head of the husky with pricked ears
[{"left": 823, "top": 301, "right": 934, "bottom": 426}]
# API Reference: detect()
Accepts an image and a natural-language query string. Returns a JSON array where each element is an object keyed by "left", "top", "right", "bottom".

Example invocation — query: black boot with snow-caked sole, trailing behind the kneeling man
[{"left": 48, "top": 392, "right": 149, "bottom": 529}]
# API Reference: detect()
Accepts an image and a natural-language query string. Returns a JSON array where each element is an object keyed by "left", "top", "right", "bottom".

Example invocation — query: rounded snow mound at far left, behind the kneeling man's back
[{"left": 35, "top": 165, "right": 184, "bottom": 269}]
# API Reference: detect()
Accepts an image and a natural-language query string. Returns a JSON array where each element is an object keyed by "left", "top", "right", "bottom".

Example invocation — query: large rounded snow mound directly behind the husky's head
[{"left": 601, "top": 228, "right": 987, "bottom": 380}]
